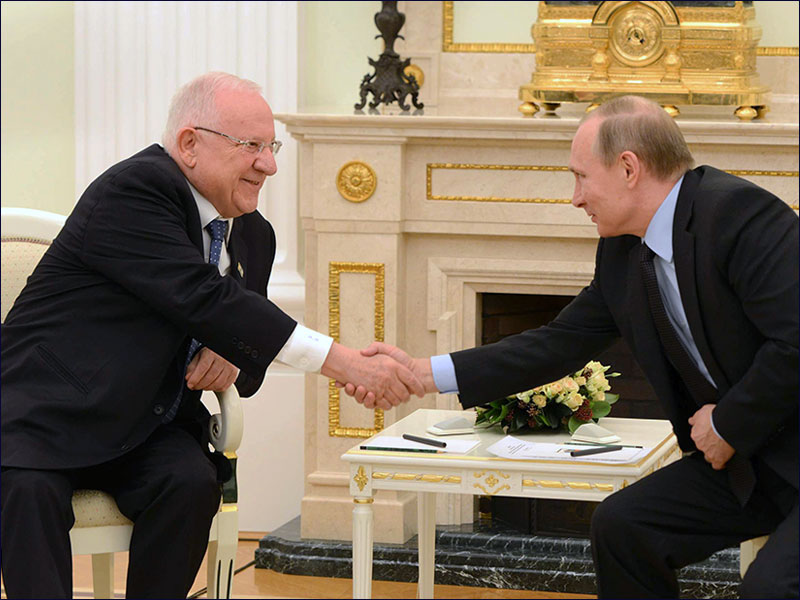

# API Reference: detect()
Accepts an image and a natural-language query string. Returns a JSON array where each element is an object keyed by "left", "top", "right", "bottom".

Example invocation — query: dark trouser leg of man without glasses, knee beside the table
[{"left": 591, "top": 454, "right": 782, "bottom": 598}]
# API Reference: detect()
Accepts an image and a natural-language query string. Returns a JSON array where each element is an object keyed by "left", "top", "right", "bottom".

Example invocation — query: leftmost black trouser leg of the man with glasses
[{"left": 0, "top": 468, "right": 75, "bottom": 598}]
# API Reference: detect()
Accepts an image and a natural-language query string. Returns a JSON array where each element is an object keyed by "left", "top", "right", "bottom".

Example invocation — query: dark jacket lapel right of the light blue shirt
[{"left": 672, "top": 171, "right": 730, "bottom": 393}]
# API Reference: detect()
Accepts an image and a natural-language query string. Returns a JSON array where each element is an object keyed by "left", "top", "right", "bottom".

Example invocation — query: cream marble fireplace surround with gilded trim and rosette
[{"left": 276, "top": 108, "right": 798, "bottom": 543}]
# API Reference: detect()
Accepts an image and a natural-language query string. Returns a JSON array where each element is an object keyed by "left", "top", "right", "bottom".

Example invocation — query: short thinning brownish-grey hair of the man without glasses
[{"left": 584, "top": 96, "right": 694, "bottom": 181}]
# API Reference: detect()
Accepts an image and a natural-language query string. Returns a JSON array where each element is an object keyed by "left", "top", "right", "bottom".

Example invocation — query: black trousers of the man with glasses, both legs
[{"left": 0, "top": 426, "right": 220, "bottom": 598}]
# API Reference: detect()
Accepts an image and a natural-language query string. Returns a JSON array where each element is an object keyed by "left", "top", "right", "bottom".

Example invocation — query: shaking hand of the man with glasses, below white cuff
[{"left": 321, "top": 342, "right": 425, "bottom": 409}]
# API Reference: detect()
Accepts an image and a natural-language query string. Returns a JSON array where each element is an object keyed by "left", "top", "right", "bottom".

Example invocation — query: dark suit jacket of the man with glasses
[{"left": 1, "top": 145, "right": 296, "bottom": 468}]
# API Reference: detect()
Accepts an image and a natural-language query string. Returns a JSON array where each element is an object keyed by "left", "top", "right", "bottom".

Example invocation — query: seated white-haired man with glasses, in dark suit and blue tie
[{"left": 2, "top": 73, "right": 423, "bottom": 598}]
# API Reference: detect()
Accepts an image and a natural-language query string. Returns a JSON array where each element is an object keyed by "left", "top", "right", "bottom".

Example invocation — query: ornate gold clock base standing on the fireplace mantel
[{"left": 519, "top": 1, "right": 769, "bottom": 120}]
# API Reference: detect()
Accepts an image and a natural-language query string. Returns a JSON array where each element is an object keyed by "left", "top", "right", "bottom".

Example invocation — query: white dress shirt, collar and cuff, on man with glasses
[{"left": 187, "top": 180, "right": 333, "bottom": 373}]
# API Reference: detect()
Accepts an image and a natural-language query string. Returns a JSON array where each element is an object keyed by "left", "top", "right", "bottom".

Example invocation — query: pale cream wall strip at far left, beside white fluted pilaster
[{"left": 0, "top": 2, "right": 75, "bottom": 214}]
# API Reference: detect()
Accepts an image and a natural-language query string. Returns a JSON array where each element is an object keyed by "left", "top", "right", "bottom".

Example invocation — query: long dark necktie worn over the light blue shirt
[{"left": 639, "top": 243, "right": 756, "bottom": 506}]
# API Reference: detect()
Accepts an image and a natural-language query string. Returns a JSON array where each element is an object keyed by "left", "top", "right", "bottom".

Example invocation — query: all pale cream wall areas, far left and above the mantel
[{"left": 0, "top": 1, "right": 798, "bottom": 214}]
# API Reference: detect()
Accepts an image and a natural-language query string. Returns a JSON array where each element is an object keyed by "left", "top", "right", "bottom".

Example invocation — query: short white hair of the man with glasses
[{"left": 161, "top": 71, "right": 261, "bottom": 155}]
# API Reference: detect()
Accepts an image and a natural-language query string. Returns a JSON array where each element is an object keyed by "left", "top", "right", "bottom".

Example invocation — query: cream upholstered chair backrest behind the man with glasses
[{"left": 0, "top": 208, "right": 66, "bottom": 321}]
